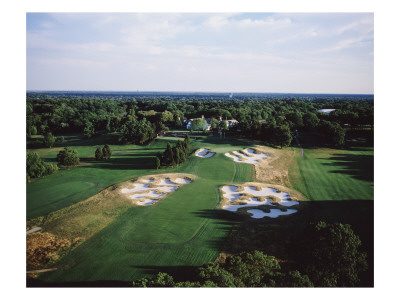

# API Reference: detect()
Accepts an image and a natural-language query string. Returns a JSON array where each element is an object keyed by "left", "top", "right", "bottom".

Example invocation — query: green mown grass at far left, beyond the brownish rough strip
[{"left": 26, "top": 138, "right": 186, "bottom": 220}]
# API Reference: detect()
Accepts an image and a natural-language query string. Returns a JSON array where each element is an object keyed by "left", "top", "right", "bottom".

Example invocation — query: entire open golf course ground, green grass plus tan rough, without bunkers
[{"left": 27, "top": 132, "right": 373, "bottom": 285}]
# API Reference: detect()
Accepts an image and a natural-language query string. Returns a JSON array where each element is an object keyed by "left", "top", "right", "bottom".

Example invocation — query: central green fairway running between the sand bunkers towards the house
[{"left": 32, "top": 137, "right": 254, "bottom": 282}]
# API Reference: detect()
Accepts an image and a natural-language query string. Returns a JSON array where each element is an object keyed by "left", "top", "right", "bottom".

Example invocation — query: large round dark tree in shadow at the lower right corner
[{"left": 296, "top": 222, "right": 367, "bottom": 287}]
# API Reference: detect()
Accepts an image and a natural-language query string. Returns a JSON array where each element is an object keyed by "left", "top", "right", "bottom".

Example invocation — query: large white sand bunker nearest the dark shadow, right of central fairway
[{"left": 221, "top": 185, "right": 299, "bottom": 219}]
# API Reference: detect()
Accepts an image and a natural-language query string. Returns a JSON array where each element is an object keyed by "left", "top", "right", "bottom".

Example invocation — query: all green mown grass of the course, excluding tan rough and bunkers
[{"left": 27, "top": 132, "right": 373, "bottom": 282}]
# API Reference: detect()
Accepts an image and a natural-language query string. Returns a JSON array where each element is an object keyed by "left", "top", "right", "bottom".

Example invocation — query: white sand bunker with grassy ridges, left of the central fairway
[{"left": 120, "top": 174, "right": 194, "bottom": 206}]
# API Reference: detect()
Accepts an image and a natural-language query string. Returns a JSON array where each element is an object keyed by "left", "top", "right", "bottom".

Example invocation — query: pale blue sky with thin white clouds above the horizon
[{"left": 26, "top": 13, "right": 374, "bottom": 94}]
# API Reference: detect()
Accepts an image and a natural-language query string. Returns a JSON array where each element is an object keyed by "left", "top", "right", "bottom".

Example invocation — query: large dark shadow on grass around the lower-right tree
[{"left": 205, "top": 200, "right": 374, "bottom": 286}]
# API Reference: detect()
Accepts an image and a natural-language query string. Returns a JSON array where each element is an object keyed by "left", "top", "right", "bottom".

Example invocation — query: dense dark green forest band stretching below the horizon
[{"left": 26, "top": 92, "right": 374, "bottom": 148}]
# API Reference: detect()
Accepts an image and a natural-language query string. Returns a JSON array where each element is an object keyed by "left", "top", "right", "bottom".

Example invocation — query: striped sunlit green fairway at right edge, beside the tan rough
[{"left": 291, "top": 147, "right": 374, "bottom": 201}]
